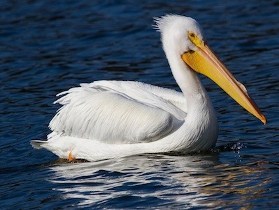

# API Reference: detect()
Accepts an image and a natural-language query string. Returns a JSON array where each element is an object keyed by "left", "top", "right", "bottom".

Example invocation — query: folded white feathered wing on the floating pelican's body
[{"left": 49, "top": 81, "right": 187, "bottom": 143}]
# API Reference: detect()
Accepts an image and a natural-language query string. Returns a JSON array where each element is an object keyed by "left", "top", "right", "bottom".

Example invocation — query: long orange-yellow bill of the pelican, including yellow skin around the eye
[{"left": 182, "top": 32, "right": 266, "bottom": 124}]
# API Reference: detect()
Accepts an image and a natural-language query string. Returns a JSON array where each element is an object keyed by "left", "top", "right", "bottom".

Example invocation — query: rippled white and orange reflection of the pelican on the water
[{"left": 49, "top": 154, "right": 270, "bottom": 208}]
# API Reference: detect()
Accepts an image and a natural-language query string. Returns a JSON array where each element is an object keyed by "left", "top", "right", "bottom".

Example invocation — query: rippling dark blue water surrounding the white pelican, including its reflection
[{"left": 0, "top": 0, "right": 279, "bottom": 209}]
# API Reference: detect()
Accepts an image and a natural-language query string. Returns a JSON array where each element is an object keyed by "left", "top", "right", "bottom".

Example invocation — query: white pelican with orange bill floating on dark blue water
[{"left": 32, "top": 15, "right": 266, "bottom": 161}]
